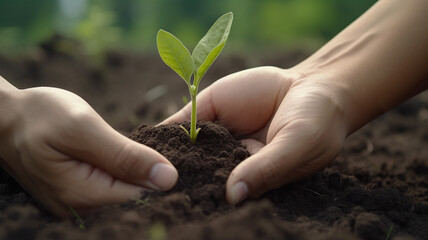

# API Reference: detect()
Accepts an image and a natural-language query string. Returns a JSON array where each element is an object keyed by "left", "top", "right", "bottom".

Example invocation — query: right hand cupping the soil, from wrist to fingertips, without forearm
[{"left": 163, "top": 67, "right": 347, "bottom": 204}]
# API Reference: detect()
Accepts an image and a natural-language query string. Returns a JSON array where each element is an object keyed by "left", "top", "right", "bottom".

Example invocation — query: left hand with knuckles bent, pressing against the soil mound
[{"left": 0, "top": 88, "right": 177, "bottom": 217}]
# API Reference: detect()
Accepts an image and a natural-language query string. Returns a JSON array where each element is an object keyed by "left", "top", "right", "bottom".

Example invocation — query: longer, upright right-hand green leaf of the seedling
[{"left": 192, "top": 12, "right": 233, "bottom": 86}]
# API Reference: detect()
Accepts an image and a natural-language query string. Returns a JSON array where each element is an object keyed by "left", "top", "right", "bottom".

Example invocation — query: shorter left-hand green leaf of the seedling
[{"left": 156, "top": 29, "right": 193, "bottom": 85}]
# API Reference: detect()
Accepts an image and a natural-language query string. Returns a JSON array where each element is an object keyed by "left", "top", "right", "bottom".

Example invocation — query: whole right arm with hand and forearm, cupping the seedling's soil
[{"left": 164, "top": 0, "right": 428, "bottom": 204}]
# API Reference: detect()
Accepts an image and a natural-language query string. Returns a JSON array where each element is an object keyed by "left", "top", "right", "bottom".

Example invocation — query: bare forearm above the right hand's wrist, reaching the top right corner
[{"left": 296, "top": 0, "right": 428, "bottom": 135}]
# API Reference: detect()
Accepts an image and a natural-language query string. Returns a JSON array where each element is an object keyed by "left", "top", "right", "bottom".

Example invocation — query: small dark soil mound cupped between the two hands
[{"left": 131, "top": 122, "right": 250, "bottom": 216}]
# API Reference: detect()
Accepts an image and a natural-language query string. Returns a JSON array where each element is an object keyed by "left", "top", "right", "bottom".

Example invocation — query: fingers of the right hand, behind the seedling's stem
[{"left": 163, "top": 67, "right": 291, "bottom": 135}]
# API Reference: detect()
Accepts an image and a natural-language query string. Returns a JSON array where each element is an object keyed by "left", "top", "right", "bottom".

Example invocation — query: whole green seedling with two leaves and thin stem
[{"left": 157, "top": 12, "right": 233, "bottom": 144}]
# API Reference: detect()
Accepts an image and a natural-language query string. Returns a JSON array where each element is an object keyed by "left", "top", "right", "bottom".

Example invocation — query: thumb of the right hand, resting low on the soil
[{"left": 226, "top": 136, "right": 334, "bottom": 204}]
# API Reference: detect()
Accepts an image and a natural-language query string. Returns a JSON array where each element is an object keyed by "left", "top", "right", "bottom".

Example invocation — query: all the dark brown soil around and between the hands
[{"left": 0, "top": 38, "right": 428, "bottom": 240}]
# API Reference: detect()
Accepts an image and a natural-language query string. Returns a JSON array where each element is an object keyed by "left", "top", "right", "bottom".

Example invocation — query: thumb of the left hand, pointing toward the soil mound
[{"left": 58, "top": 115, "right": 178, "bottom": 190}]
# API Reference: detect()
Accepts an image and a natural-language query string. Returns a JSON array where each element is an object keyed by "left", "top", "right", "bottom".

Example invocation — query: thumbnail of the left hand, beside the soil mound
[{"left": 149, "top": 163, "right": 178, "bottom": 190}]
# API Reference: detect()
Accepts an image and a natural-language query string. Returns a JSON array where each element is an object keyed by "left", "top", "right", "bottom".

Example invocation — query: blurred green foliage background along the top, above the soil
[{"left": 0, "top": 0, "right": 375, "bottom": 55}]
